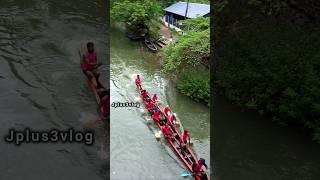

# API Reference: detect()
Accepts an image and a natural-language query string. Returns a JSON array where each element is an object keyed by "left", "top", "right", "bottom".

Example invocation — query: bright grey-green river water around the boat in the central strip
[{"left": 110, "top": 25, "right": 210, "bottom": 179}]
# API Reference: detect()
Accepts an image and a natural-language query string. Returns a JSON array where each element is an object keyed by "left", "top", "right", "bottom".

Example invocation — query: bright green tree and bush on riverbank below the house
[{"left": 163, "top": 18, "right": 210, "bottom": 103}]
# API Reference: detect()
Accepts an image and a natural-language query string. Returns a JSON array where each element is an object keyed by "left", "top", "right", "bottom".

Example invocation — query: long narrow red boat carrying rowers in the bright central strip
[{"left": 137, "top": 80, "right": 210, "bottom": 180}]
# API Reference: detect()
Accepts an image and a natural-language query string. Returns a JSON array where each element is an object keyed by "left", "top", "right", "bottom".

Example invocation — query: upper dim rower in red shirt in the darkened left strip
[{"left": 81, "top": 42, "right": 99, "bottom": 88}]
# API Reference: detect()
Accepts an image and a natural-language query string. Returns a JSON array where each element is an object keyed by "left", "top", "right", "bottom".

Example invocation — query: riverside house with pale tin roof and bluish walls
[{"left": 162, "top": 2, "right": 210, "bottom": 31}]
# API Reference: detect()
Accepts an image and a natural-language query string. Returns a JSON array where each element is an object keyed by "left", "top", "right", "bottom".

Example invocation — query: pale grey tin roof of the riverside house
[{"left": 164, "top": 2, "right": 210, "bottom": 18}]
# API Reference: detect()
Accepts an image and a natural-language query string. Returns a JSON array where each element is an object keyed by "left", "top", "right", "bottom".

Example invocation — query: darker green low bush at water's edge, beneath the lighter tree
[{"left": 177, "top": 70, "right": 210, "bottom": 103}]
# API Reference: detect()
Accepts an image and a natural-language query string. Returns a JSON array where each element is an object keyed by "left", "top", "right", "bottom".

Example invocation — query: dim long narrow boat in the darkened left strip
[{"left": 79, "top": 51, "right": 108, "bottom": 127}]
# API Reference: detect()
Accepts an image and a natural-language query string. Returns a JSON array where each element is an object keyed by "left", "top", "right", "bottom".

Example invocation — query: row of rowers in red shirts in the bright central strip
[{"left": 135, "top": 75, "right": 207, "bottom": 173}]
